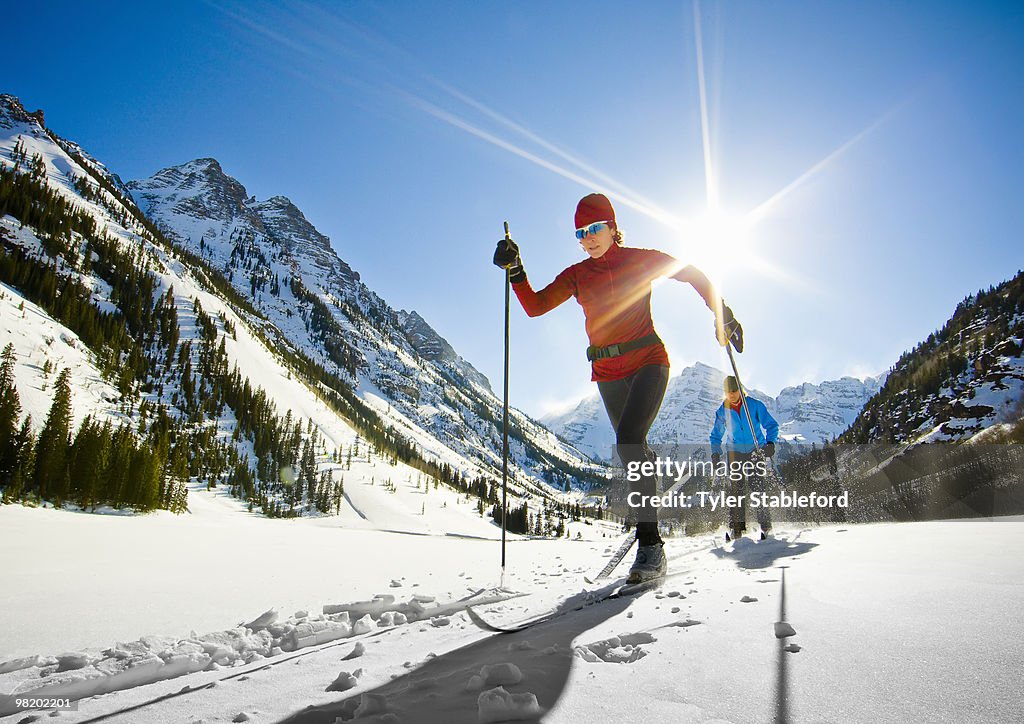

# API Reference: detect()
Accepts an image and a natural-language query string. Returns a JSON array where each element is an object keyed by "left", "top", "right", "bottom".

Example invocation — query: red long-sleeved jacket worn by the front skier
[{"left": 512, "top": 244, "right": 710, "bottom": 382}]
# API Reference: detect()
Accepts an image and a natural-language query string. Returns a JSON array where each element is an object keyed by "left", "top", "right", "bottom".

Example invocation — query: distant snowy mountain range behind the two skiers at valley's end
[{"left": 541, "top": 363, "right": 883, "bottom": 461}]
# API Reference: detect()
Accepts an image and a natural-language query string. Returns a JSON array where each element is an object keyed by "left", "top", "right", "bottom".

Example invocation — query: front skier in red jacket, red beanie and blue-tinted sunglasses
[{"left": 494, "top": 194, "right": 743, "bottom": 583}]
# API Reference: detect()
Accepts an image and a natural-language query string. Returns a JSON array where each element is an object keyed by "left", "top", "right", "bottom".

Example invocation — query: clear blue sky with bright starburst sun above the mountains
[{"left": 0, "top": 0, "right": 1024, "bottom": 415}]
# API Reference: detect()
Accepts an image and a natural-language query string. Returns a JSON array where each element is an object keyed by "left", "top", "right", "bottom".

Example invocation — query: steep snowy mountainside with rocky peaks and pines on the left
[{"left": 0, "top": 95, "right": 602, "bottom": 534}]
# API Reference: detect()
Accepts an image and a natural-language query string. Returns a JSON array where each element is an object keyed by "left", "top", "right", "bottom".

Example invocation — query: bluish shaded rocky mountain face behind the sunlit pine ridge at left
[{"left": 128, "top": 159, "right": 591, "bottom": 497}]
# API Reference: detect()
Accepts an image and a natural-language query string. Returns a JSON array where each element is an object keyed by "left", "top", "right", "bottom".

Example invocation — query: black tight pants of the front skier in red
[{"left": 597, "top": 365, "right": 669, "bottom": 546}]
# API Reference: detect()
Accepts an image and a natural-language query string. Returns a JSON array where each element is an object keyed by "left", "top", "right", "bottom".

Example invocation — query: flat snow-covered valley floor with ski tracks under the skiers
[{"left": 0, "top": 493, "right": 1024, "bottom": 724}]
